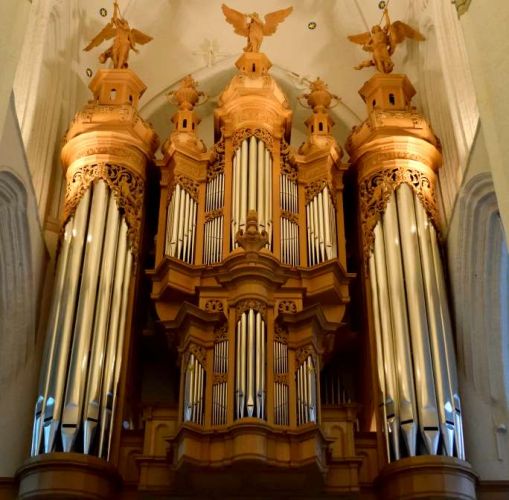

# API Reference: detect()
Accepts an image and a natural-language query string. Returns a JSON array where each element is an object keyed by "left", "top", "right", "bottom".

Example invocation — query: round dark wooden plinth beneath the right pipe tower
[{"left": 377, "top": 455, "right": 477, "bottom": 500}]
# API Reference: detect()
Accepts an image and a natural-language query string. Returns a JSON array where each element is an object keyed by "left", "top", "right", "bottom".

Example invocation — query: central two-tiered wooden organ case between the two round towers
[{"left": 147, "top": 26, "right": 359, "bottom": 495}]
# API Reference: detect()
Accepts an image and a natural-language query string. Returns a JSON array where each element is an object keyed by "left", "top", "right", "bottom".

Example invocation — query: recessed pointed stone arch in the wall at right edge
[{"left": 450, "top": 173, "right": 509, "bottom": 407}]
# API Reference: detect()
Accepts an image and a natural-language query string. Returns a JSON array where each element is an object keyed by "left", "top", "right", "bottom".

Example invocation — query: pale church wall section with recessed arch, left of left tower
[{"left": 0, "top": 99, "right": 47, "bottom": 477}]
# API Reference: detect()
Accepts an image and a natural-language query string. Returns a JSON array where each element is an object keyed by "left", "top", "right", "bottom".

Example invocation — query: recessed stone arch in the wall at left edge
[{"left": 0, "top": 169, "right": 33, "bottom": 384}]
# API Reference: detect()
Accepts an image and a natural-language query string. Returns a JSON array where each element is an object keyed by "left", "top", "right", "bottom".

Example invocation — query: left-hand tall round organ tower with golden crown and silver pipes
[{"left": 20, "top": 29, "right": 158, "bottom": 498}]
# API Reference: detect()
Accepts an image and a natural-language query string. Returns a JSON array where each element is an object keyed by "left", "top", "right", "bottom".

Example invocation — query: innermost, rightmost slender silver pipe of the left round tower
[{"left": 99, "top": 219, "right": 129, "bottom": 456}]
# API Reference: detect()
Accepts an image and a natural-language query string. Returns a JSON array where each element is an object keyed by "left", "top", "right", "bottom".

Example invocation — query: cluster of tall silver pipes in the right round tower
[{"left": 369, "top": 184, "right": 464, "bottom": 459}]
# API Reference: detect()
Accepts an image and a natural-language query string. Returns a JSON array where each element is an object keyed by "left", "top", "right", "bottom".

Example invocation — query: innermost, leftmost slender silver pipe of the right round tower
[{"left": 374, "top": 223, "right": 401, "bottom": 460}]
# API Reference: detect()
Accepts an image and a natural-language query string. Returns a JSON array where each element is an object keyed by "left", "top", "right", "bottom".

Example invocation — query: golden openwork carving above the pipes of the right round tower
[{"left": 359, "top": 167, "right": 440, "bottom": 264}]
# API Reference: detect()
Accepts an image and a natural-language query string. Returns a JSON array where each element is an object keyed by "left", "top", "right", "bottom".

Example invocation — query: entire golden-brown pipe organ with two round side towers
[{"left": 16, "top": 6, "right": 475, "bottom": 499}]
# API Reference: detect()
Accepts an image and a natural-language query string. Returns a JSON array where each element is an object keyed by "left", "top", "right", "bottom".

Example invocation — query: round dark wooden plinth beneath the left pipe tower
[{"left": 17, "top": 453, "right": 121, "bottom": 500}]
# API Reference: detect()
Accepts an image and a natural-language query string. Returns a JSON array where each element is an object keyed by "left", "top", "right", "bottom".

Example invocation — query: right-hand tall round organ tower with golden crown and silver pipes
[{"left": 346, "top": 66, "right": 475, "bottom": 498}]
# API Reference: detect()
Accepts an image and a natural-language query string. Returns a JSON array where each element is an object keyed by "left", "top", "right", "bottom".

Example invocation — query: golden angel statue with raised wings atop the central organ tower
[{"left": 222, "top": 4, "right": 293, "bottom": 52}]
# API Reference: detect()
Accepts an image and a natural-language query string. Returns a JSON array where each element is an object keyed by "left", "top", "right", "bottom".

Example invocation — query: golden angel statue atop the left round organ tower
[{"left": 84, "top": 0, "right": 152, "bottom": 69}]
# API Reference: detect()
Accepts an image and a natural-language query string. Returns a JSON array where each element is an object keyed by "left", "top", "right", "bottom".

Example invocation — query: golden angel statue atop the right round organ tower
[{"left": 348, "top": 8, "right": 426, "bottom": 73}]
